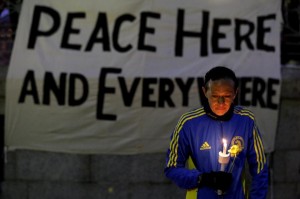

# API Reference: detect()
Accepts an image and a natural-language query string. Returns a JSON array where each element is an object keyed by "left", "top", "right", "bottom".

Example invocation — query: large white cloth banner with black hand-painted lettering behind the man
[{"left": 5, "top": 0, "right": 281, "bottom": 154}]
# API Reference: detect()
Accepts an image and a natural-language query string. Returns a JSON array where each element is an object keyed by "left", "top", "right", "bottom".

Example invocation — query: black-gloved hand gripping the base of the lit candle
[{"left": 199, "top": 171, "right": 232, "bottom": 192}]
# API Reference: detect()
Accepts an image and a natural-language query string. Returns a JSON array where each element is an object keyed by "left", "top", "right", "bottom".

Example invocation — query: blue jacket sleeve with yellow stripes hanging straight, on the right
[{"left": 248, "top": 123, "right": 268, "bottom": 199}]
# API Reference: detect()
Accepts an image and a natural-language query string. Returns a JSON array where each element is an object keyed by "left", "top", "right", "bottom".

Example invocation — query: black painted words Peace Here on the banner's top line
[{"left": 27, "top": 6, "right": 276, "bottom": 57}]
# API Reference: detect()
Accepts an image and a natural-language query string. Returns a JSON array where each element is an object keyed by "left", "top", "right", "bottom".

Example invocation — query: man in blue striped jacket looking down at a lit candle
[{"left": 164, "top": 66, "right": 268, "bottom": 199}]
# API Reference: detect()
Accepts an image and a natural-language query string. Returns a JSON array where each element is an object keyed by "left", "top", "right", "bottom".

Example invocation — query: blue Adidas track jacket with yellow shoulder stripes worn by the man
[{"left": 164, "top": 106, "right": 268, "bottom": 199}]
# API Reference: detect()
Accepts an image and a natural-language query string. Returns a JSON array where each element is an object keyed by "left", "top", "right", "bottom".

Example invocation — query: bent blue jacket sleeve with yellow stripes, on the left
[{"left": 164, "top": 118, "right": 200, "bottom": 189}]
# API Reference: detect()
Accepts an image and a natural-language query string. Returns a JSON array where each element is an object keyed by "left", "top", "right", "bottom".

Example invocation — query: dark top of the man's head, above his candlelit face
[{"left": 204, "top": 66, "right": 238, "bottom": 89}]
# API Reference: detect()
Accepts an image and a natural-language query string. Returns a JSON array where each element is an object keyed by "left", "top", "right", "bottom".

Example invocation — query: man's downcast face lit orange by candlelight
[{"left": 202, "top": 79, "right": 236, "bottom": 116}]
